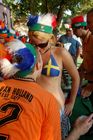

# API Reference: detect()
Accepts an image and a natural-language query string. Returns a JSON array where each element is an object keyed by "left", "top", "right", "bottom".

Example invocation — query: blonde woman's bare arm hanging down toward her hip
[{"left": 62, "top": 48, "right": 80, "bottom": 114}]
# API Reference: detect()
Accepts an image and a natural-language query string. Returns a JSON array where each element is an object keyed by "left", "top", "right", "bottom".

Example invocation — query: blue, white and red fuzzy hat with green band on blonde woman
[{"left": 27, "top": 13, "right": 57, "bottom": 34}]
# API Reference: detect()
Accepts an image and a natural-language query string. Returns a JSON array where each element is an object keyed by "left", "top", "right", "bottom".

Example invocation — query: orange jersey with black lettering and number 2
[{"left": 0, "top": 79, "right": 61, "bottom": 140}]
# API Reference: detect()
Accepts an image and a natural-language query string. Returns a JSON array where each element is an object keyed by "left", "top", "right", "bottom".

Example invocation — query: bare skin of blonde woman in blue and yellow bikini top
[{"left": 29, "top": 30, "right": 79, "bottom": 115}]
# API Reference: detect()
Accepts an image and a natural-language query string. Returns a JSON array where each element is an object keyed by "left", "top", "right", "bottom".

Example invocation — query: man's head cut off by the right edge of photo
[{"left": 87, "top": 8, "right": 93, "bottom": 34}]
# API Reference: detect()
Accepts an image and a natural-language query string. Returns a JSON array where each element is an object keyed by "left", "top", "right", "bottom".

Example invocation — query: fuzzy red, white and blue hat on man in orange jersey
[{"left": 0, "top": 39, "right": 42, "bottom": 80}]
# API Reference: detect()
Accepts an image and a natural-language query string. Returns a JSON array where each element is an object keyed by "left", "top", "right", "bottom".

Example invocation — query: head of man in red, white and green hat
[{"left": 71, "top": 16, "right": 87, "bottom": 37}]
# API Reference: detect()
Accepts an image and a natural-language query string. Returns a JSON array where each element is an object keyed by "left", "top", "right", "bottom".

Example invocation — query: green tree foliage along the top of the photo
[{"left": 3, "top": 0, "right": 93, "bottom": 25}]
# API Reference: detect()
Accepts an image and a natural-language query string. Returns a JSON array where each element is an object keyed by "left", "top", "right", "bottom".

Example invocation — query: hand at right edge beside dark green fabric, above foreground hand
[{"left": 81, "top": 84, "right": 92, "bottom": 98}]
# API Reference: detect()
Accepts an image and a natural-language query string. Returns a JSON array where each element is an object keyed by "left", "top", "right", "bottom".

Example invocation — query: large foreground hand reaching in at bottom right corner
[{"left": 74, "top": 114, "right": 93, "bottom": 136}]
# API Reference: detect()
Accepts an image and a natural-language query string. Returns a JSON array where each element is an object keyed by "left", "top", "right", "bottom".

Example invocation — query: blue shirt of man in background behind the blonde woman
[{"left": 59, "top": 34, "right": 81, "bottom": 56}]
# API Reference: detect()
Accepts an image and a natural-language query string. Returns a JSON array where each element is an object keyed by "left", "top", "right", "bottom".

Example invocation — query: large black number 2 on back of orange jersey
[{"left": 0, "top": 102, "right": 23, "bottom": 140}]
